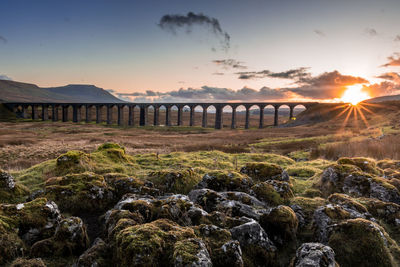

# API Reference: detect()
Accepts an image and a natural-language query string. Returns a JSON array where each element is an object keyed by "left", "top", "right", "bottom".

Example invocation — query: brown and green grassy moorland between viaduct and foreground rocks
[{"left": 0, "top": 100, "right": 400, "bottom": 170}]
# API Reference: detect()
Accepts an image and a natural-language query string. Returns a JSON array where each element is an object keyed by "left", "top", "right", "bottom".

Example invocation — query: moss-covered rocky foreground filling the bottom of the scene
[{"left": 0, "top": 144, "right": 400, "bottom": 267}]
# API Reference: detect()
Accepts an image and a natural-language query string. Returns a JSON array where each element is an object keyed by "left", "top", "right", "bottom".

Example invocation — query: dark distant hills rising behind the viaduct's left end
[{"left": 0, "top": 80, "right": 124, "bottom": 103}]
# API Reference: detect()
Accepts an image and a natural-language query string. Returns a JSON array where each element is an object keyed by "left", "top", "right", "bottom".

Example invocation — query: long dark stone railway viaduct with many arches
[{"left": 5, "top": 102, "right": 318, "bottom": 129}]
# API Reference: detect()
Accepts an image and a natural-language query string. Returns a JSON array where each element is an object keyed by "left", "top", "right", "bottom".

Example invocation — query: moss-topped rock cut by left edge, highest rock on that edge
[{"left": 0, "top": 169, "right": 29, "bottom": 203}]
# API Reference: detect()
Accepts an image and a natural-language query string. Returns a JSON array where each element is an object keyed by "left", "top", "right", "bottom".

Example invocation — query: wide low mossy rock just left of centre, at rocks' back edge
[{"left": 148, "top": 168, "right": 201, "bottom": 194}]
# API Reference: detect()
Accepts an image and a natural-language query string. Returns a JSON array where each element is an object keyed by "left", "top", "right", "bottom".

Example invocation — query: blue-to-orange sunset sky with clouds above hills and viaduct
[{"left": 0, "top": 0, "right": 400, "bottom": 101}]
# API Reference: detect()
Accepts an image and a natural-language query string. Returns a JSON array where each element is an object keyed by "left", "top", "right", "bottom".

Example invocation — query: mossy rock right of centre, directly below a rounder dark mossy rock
[{"left": 251, "top": 180, "right": 294, "bottom": 206}]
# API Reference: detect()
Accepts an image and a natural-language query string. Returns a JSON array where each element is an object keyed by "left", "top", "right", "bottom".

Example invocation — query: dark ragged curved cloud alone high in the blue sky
[{"left": 158, "top": 12, "right": 231, "bottom": 50}]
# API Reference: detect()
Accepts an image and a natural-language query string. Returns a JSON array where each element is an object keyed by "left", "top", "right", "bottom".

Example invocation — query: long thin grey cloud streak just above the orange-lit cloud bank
[{"left": 236, "top": 67, "right": 310, "bottom": 81}]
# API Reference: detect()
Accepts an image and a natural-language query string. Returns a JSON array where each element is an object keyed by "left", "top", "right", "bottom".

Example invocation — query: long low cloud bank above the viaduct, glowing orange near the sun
[{"left": 117, "top": 68, "right": 376, "bottom": 103}]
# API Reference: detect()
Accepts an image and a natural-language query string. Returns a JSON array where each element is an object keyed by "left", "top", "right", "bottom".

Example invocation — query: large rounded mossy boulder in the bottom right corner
[{"left": 328, "top": 218, "right": 399, "bottom": 267}]
